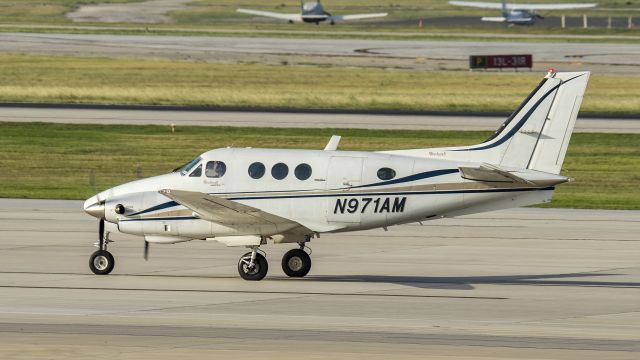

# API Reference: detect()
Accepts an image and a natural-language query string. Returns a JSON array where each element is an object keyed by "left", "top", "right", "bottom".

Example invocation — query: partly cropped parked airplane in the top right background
[{"left": 449, "top": 0, "right": 598, "bottom": 25}]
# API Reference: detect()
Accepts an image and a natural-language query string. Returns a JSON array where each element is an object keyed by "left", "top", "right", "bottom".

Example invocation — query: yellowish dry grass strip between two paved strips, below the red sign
[{"left": 0, "top": 54, "right": 640, "bottom": 114}]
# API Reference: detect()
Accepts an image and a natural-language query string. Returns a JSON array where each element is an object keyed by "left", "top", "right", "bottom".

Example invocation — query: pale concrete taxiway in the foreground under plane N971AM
[{"left": 0, "top": 199, "right": 640, "bottom": 359}]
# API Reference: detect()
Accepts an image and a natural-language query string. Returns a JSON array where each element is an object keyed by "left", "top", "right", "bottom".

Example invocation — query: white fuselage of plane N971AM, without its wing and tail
[{"left": 86, "top": 148, "right": 553, "bottom": 242}]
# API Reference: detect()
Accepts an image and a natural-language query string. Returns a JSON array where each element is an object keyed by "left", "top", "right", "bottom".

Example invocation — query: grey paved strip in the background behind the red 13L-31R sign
[{"left": 0, "top": 33, "right": 640, "bottom": 75}]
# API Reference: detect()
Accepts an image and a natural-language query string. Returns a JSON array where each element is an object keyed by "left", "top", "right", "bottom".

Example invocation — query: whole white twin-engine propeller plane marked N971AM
[{"left": 84, "top": 72, "right": 589, "bottom": 280}]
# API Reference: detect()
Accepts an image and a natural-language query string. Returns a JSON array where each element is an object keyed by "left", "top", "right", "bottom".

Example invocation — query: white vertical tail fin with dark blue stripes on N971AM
[{"left": 400, "top": 72, "right": 589, "bottom": 174}]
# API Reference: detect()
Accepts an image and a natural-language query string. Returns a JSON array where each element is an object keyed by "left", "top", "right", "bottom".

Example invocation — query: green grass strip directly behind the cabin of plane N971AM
[{"left": 0, "top": 123, "right": 640, "bottom": 209}]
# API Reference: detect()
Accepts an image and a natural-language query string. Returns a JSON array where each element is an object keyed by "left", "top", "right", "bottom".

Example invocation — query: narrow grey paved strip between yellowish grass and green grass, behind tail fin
[{"left": 0, "top": 107, "right": 640, "bottom": 133}]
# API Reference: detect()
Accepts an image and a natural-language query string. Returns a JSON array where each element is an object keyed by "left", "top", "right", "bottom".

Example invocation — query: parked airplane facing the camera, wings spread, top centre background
[{"left": 237, "top": 0, "right": 387, "bottom": 25}]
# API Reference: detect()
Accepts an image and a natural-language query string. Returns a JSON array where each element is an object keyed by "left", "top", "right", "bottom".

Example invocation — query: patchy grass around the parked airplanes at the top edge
[{"left": 0, "top": 0, "right": 640, "bottom": 41}]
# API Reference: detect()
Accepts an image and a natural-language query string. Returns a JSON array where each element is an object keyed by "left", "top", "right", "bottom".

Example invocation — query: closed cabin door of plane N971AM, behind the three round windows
[{"left": 327, "top": 156, "right": 363, "bottom": 223}]
